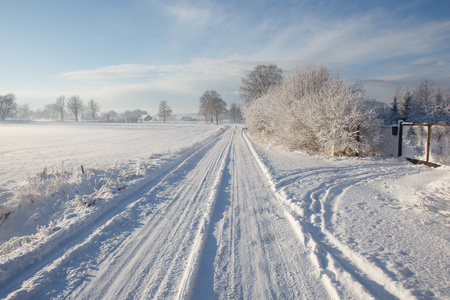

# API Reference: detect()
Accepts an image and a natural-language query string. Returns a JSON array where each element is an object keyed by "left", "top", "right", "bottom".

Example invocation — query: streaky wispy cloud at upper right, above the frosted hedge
[{"left": 253, "top": 13, "right": 450, "bottom": 67}]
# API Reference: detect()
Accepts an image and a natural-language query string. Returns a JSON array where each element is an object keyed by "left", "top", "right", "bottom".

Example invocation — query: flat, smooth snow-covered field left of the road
[{"left": 0, "top": 122, "right": 221, "bottom": 188}]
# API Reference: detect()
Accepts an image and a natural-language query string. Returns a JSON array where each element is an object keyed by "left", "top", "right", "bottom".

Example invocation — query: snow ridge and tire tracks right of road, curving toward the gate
[{"left": 245, "top": 137, "right": 414, "bottom": 299}]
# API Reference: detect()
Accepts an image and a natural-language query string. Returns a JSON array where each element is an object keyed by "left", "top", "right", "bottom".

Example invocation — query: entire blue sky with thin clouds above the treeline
[{"left": 0, "top": 0, "right": 450, "bottom": 114}]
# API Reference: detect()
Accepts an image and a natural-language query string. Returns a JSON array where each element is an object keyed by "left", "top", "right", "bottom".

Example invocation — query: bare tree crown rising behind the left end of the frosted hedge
[{"left": 239, "top": 65, "right": 283, "bottom": 106}]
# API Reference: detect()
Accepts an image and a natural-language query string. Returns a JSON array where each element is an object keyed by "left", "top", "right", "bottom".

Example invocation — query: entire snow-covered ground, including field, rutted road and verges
[{"left": 0, "top": 124, "right": 450, "bottom": 299}]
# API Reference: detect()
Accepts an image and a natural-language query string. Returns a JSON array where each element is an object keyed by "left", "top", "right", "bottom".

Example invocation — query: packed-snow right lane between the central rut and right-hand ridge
[{"left": 193, "top": 129, "right": 327, "bottom": 299}]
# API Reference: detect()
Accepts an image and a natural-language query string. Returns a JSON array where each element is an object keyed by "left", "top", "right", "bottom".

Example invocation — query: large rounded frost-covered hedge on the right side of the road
[{"left": 244, "top": 66, "right": 381, "bottom": 156}]
